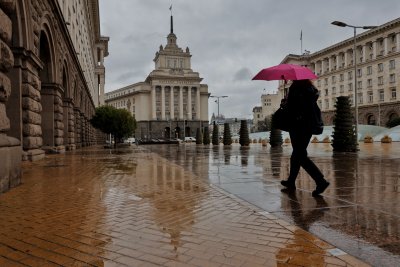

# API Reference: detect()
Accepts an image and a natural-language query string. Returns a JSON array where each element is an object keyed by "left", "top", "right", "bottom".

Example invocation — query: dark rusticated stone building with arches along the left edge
[{"left": 0, "top": 0, "right": 108, "bottom": 192}]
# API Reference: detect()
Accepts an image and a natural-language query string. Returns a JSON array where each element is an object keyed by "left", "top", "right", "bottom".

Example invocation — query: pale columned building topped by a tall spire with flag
[{"left": 105, "top": 16, "right": 209, "bottom": 139}]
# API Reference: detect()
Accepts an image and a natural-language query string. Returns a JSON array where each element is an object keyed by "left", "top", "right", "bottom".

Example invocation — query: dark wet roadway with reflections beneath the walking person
[{"left": 147, "top": 143, "right": 400, "bottom": 266}]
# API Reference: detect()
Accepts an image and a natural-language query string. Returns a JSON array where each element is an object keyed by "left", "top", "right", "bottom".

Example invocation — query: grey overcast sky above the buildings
[{"left": 99, "top": 0, "right": 400, "bottom": 118}]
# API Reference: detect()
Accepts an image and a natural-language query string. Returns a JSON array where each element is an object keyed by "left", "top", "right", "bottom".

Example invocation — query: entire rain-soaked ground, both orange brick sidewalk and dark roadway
[{"left": 0, "top": 144, "right": 400, "bottom": 266}]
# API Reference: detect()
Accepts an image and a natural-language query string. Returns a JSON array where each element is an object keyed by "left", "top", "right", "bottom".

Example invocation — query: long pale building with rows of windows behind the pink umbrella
[{"left": 279, "top": 18, "right": 400, "bottom": 126}]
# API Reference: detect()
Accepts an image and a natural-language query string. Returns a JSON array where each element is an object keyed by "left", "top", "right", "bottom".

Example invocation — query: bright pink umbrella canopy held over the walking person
[{"left": 252, "top": 64, "right": 318, "bottom": 81}]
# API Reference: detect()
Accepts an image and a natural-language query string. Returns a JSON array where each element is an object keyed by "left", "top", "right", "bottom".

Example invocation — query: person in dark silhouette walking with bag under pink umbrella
[{"left": 281, "top": 80, "right": 329, "bottom": 197}]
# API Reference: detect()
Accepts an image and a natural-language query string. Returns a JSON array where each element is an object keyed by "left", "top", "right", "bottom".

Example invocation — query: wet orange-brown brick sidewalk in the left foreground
[{"left": 0, "top": 146, "right": 369, "bottom": 267}]
